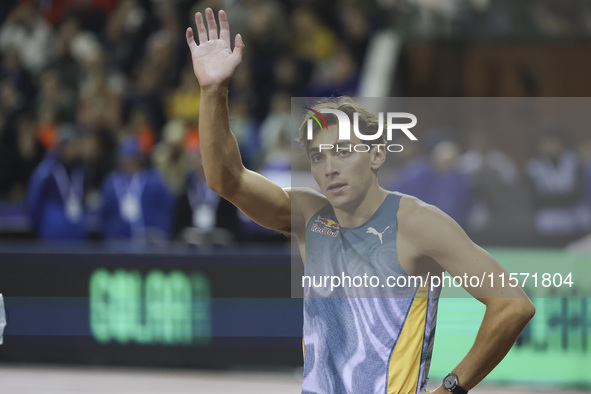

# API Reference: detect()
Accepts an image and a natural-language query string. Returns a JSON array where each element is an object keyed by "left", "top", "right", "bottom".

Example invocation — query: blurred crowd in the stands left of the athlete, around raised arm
[{"left": 0, "top": 0, "right": 379, "bottom": 242}]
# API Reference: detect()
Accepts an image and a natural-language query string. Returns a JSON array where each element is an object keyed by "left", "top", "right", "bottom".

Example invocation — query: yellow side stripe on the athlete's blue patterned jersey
[{"left": 387, "top": 284, "right": 429, "bottom": 394}]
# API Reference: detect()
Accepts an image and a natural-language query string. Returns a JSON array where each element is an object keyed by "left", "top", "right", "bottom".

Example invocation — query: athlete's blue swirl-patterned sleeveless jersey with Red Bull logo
[{"left": 302, "top": 194, "right": 440, "bottom": 394}]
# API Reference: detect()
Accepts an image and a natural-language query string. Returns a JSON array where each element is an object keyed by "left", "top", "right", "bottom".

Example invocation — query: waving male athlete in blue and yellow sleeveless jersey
[{"left": 186, "top": 8, "right": 534, "bottom": 393}]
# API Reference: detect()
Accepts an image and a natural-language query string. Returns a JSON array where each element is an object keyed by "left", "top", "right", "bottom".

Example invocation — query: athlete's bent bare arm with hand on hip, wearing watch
[{"left": 401, "top": 198, "right": 535, "bottom": 394}]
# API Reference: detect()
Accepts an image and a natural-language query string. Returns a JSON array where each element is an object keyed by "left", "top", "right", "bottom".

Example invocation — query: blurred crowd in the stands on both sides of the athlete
[{"left": 0, "top": 0, "right": 591, "bottom": 245}]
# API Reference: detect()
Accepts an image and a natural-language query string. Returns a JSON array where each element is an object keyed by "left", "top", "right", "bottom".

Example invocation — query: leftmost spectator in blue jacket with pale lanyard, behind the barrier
[{"left": 27, "top": 124, "right": 86, "bottom": 240}]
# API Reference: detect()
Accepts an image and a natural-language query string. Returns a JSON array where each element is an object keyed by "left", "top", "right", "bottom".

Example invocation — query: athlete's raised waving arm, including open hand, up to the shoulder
[{"left": 186, "top": 8, "right": 291, "bottom": 232}]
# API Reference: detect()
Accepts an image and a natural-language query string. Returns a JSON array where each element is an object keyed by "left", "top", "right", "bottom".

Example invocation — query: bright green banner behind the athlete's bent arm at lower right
[{"left": 429, "top": 249, "right": 591, "bottom": 387}]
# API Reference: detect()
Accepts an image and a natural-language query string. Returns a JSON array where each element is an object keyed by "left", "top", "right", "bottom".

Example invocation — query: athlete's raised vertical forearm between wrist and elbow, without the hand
[{"left": 199, "top": 86, "right": 244, "bottom": 197}]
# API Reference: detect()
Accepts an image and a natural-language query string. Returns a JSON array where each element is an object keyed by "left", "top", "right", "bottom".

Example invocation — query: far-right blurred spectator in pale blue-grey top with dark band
[{"left": 526, "top": 126, "right": 591, "bottom": 247}]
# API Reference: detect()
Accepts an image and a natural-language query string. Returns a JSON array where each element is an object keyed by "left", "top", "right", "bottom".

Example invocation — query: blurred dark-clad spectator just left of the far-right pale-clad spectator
[{"left": 459, "top": 131, "right": 534, "bottom": 245}]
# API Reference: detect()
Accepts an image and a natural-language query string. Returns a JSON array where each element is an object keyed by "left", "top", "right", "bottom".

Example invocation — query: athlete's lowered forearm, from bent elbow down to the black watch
[{"left": 436, "top": 298, "right": 534, "bottom": 393}]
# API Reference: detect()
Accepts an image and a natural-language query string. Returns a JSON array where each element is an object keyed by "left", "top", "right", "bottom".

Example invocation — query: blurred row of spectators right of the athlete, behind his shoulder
[{"left": 388, "top": 124, "right": 591, "bottom": 247}]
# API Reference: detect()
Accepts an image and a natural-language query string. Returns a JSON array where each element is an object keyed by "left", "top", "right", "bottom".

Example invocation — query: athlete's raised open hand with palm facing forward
[{"left": 186, "top": 8, "right": 244, "bottom": 90}]
